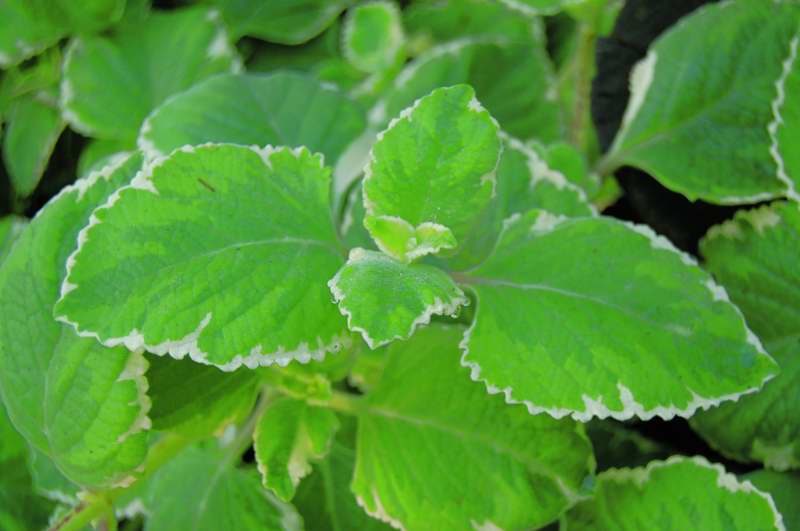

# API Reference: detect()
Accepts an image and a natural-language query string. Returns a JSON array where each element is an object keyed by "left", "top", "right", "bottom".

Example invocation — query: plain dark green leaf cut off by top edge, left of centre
[{"left": 210, "top": 0, "right": 352, "bottom": 44}]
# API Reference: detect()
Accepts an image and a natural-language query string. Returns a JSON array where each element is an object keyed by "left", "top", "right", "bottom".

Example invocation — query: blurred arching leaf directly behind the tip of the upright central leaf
[{"left": 370, "top": 36, "right": 562, "bottom": 142}]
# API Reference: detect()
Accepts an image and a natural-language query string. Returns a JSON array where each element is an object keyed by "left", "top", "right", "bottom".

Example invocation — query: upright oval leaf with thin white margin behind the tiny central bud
[{"left": 362, "top": 85, "right": 501, "bottom": 254}]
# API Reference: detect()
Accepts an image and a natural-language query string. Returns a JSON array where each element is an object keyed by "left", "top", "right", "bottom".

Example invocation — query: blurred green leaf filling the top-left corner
[{"left": 0, "top": 0, "right": 125, "bottom": 68}]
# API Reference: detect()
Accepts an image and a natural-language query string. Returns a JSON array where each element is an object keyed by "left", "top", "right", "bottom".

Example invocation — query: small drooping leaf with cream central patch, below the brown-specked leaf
[{"left": 253, "top": 398, "right": 339, "bottom": 502}]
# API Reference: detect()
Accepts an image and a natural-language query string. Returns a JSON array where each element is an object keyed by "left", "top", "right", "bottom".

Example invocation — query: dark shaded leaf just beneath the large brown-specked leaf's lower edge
[{"left": 147, "top": 356, "right": 258, "bottom": 437}]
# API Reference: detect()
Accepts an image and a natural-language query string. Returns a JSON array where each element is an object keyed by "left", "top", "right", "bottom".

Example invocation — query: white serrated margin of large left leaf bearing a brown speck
[{"left": 55, "top": 142, "right": 351, "bottom": 372}]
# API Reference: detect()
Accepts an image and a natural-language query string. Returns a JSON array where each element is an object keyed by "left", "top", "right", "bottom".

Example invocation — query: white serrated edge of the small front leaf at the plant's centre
[{"left": 328, "top": 247, "right": 469, "bottom": 350}]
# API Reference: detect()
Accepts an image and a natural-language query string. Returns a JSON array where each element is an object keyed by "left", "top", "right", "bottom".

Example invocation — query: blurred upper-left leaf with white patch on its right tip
[{"left": 60, "top": 7, "right": 240, "bottom": 140}]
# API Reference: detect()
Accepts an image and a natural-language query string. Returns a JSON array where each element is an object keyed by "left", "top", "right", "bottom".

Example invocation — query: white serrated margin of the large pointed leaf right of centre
[{"left": 459, "top": 211, "right": 775, "bottom": 422}]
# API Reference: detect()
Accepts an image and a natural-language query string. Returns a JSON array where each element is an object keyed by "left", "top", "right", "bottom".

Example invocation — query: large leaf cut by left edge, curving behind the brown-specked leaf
[{"left": 0, "top": 155, "right": 149, "bottom": 486}]
